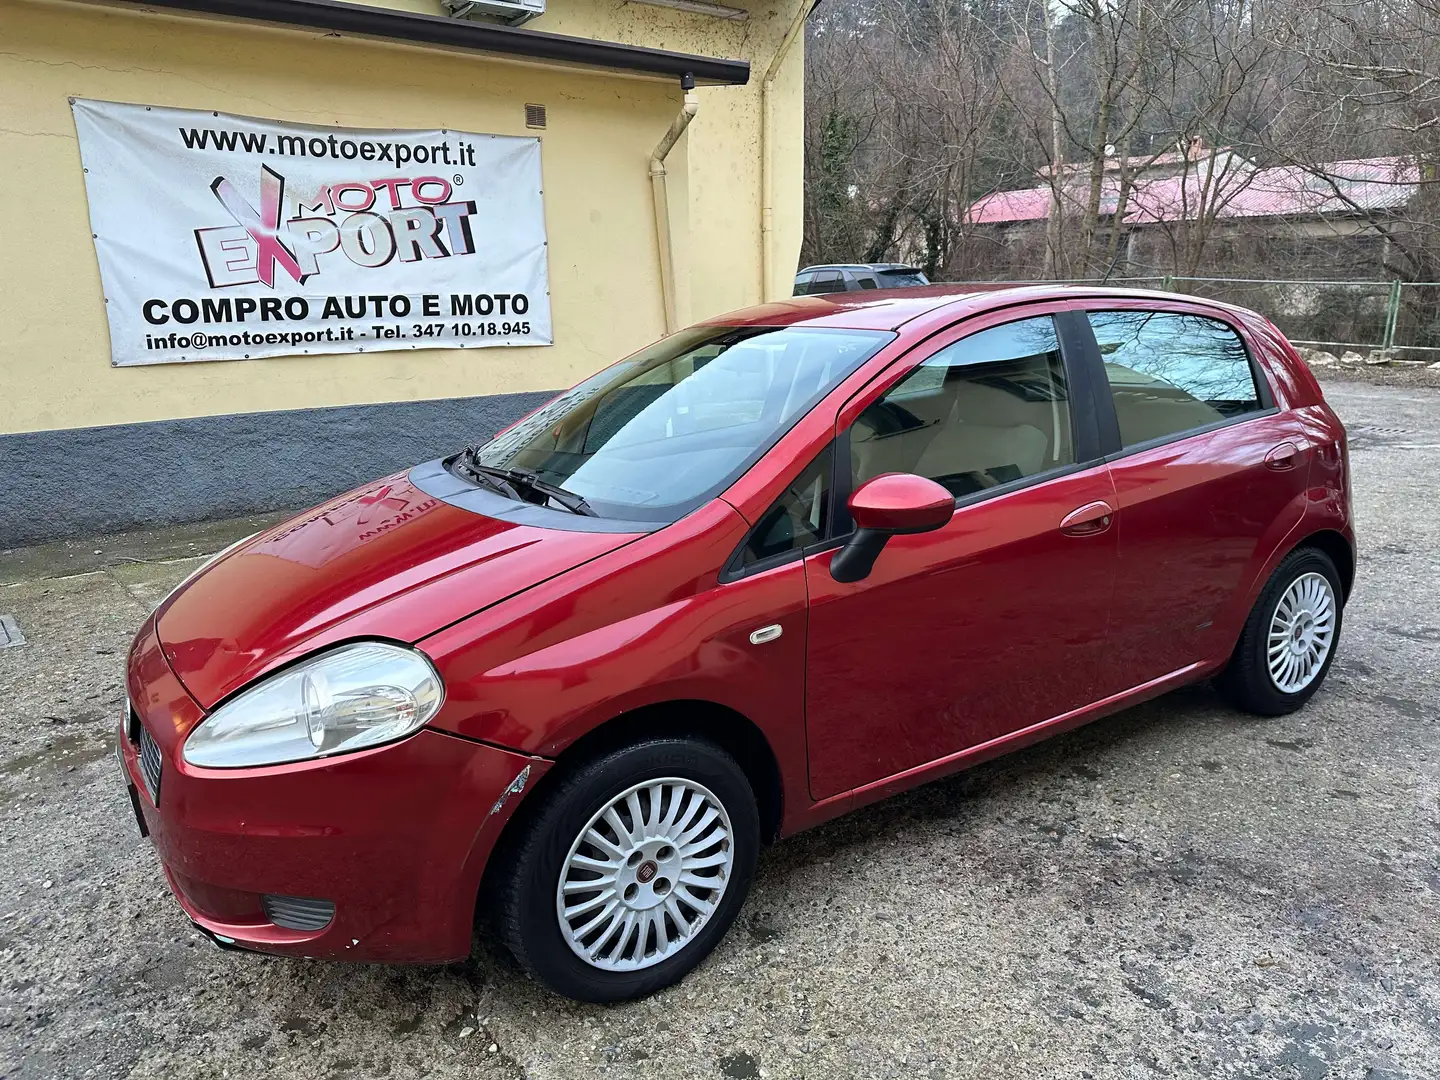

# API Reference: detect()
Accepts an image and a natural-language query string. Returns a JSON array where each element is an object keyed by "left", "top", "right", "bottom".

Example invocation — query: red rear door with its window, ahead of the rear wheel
[{"left": 1087, "top": 308, "right": 1309, "bottom": 696}]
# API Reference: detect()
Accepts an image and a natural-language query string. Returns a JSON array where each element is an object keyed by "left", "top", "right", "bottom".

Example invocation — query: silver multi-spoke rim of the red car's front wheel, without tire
[{"left": 554, "top": 776, "right": 734, "bottom": 971}]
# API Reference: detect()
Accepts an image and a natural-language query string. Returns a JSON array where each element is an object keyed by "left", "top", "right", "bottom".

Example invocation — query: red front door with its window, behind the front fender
[{"left": 805, "top": 314, "right": 1115, "bottom": 799}]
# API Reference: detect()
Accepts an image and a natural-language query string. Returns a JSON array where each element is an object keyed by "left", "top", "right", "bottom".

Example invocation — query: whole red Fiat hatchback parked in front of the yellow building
[{"left": 120, "top": 287, "right": 1355, "bottom": 1001}]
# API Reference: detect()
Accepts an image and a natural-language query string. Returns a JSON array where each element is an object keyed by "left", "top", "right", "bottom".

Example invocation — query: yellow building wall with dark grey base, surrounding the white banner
[{"left": 0, "top": 0, "right": 802, "bottom": 547}]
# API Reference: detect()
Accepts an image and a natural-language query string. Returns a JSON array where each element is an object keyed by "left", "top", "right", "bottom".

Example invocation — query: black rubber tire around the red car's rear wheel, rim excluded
[{"left": 1215, "top": 547, "right": 1345, "bottom": 716}]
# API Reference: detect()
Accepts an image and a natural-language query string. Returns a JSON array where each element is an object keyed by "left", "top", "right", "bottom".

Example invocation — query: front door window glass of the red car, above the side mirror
[{"left": 850, "top": 315, "right": 1074, "bottom": 497}]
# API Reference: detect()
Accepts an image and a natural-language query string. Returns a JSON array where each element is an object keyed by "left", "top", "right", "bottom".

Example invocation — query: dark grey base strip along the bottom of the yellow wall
[{"left": 0, "top": 393, "right": 552, "bottom": 549}]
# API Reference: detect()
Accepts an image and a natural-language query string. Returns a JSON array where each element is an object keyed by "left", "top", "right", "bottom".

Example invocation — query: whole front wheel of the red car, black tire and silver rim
[{"left": 495, "top": 739, "right": 760, "bottom": 1002}]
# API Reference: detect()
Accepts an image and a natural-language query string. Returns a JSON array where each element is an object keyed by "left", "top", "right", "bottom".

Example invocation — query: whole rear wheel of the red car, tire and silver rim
[{"left": 1215, "top": 547, "right": 1344, "bottom": 716}]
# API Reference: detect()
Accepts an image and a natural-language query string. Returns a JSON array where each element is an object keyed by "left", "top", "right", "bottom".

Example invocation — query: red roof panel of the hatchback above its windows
[{"left": 703, "top": 282, "right": 1247, "bottom": 330}]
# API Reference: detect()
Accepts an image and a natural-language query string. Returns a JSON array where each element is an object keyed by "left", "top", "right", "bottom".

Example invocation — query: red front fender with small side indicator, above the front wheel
[{"left": 419, "top": 501, "right": 811, "bottom": 835}]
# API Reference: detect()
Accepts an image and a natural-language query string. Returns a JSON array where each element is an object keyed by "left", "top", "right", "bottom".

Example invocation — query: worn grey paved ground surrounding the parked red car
[{"left": 0, "top": 384, "right": 1440, "bottom": 1080}]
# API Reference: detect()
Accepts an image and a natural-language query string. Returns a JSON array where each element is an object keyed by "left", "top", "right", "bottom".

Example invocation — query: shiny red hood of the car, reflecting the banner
[{"left": 156, "top": 474, "right": 635, "bottom": 708}]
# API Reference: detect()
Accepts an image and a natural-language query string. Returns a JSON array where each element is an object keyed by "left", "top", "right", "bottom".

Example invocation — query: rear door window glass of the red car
[{"left": 1089, "top": 311, "right": 1261, "bottom": 446}]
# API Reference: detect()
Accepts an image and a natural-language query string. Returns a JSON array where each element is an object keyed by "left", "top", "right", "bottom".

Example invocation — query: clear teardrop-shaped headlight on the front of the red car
[{"left": 184, "top": 641, "right": 445, "bottom": 769}]
